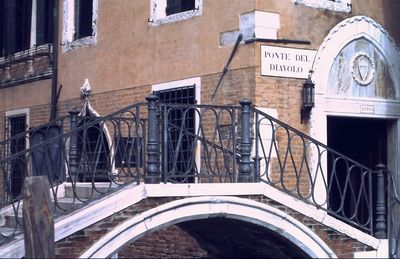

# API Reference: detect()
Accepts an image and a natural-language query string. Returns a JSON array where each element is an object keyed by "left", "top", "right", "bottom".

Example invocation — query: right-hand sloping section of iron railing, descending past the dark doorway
[{"left": 252, "top": 109, "right": 374, "bottom": 234}]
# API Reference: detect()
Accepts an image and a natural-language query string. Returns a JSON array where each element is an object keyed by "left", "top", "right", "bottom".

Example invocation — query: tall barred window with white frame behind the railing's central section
[{"left": 152, "top": 77, "right": 201, "bottom": 182}]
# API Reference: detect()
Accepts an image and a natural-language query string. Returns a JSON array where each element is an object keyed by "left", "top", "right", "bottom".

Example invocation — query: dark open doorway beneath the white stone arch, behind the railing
[{"left": 327, "top": 116, "right": 388, "bottom": 232}]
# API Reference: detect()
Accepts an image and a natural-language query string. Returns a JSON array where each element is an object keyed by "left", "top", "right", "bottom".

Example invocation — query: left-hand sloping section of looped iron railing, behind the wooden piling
[{"left": 0, "top": 104, "right": 146, "bottom": 244}]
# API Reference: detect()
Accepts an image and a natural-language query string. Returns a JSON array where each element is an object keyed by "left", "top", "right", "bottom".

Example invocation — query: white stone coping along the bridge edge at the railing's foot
[{"left": 0, "top": 183, "right": 387, "bottom": 258}]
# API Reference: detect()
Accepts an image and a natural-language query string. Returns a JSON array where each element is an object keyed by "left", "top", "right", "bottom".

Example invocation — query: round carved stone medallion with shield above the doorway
[{"left": 350, "top": 53, "right": 375, "bottom": 86}]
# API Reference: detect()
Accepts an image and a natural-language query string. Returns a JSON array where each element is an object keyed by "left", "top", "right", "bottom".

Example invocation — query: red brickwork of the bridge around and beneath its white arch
[{"left": 56, "top": 196, "right": 371, "bottom": 258}]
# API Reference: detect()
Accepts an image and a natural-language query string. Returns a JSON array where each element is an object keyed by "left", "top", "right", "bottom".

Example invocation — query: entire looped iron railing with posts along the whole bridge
[{"left": 0, "top": 95, "right": 398, "bottom": 255}]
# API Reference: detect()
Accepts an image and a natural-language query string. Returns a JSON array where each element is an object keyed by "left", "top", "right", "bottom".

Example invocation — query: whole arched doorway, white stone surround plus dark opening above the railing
[{"left": 311, "top": 16, "right": 400, "bottom": 234}]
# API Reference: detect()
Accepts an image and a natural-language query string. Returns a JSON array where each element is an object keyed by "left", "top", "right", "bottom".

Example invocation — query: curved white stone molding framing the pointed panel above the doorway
[{"left": 312, "top": 16, "right": 400, "bottom": 98}]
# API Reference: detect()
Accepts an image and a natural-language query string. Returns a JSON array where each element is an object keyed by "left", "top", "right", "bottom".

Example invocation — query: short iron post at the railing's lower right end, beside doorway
[{"left": 375, "top": 164, "right": 387, "bottom": 239}]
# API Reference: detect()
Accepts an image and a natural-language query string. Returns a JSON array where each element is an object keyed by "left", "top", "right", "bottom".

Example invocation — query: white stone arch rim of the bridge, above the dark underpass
[{"left": 81, "top": 196, "right": 336, "bottom": 258}]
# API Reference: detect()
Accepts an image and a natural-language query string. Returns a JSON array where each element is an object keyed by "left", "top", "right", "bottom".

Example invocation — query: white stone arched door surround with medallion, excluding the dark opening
[{"left": 311, "top": 16, "right": 400, "bottom": 167}]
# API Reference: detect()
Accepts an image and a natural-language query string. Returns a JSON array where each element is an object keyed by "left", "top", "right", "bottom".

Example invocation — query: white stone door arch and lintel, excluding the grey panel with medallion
[{"left": 310, "top": 16, "right": 400, "bottom": 145}]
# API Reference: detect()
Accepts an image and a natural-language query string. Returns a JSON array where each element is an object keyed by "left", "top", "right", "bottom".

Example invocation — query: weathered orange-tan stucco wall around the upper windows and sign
[{"left": 0, "top": 0, "right": 400, "bottom": 126}]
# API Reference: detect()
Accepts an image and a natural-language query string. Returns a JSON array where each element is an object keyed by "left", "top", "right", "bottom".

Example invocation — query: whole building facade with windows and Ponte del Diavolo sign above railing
[{"left": 0, "top": 0, "right": 400, "bottom": 255}]
